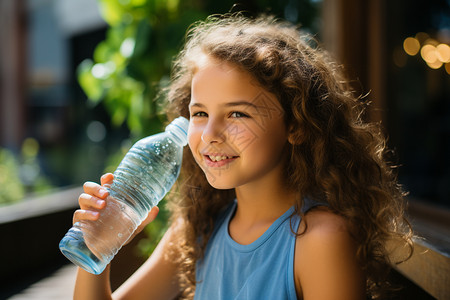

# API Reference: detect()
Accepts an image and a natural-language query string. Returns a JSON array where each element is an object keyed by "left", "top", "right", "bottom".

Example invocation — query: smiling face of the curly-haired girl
[{"left": 188, "top": 56, "right": 287, "bottom": 189}]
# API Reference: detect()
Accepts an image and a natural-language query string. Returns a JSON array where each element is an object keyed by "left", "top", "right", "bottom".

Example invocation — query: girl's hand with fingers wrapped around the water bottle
[{"left": 73, "top": 173, "right": 159, "bottom": 243}]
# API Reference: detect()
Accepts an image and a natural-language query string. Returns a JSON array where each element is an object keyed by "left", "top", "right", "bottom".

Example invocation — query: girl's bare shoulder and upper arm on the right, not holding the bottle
[{"left": 294, "top": 207, "right": 365, "bottom": 299}]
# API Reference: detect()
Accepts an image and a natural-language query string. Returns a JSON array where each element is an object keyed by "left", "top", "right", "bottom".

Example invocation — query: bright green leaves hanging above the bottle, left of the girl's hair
[{"left": 78, "top": 0, "right": 205, "bottom": 139}]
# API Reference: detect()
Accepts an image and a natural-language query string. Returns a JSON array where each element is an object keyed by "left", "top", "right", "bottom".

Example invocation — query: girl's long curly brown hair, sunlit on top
[{"left": 163, "top": 15, "right": 412, "bottom": 298}]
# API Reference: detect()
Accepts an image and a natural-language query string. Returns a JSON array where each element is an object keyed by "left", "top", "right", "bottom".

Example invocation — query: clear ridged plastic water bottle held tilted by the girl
[{"left": 59, "top": 117, "right": 189, "bottom": 274}]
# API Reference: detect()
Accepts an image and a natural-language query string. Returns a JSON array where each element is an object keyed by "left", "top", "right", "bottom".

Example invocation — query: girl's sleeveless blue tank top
[{"left": 194, "top": 199, "right": 324, "bottom": 300}]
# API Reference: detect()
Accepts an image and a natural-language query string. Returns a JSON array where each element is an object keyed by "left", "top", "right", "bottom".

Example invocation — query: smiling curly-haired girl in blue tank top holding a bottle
[{"left": 74, "top": 15, "right": 411, "bottom": 300}]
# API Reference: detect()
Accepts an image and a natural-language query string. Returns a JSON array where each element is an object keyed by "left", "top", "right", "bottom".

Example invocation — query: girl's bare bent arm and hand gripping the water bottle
[{"left": 73, "top": 174, "right": 178, "bottom": 300}]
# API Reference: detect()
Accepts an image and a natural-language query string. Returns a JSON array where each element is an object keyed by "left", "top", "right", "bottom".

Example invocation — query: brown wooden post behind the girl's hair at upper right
[{"left": 322, "top": 0, "right": 386, "bottom": 122}]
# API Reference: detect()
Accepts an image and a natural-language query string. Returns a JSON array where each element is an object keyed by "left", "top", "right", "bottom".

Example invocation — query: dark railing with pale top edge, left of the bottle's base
[{"left": 0, "top": 188, "right": 81, "bottom": 299}]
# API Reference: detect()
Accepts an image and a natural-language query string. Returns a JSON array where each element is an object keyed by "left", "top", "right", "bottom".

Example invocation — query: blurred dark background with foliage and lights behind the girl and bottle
[{"left": 0, "top": 0, "right": 450, "bottom": 298}]
